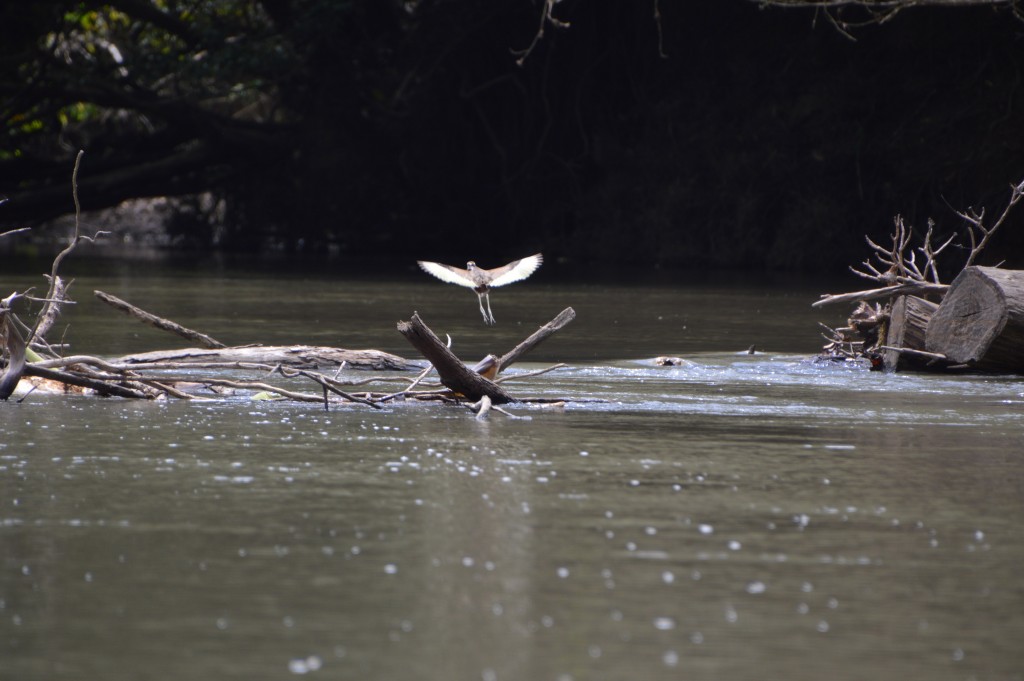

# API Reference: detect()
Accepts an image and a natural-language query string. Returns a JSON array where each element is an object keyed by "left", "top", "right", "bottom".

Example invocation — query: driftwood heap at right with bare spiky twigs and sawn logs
[{"left": 812, "top": 181, "right": 1024, "bottom": 374}]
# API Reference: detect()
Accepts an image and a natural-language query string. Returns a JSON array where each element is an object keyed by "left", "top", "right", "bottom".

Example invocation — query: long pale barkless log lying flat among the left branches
[{"left": 117, "top": 345, "right": 422, "bottom": 371}]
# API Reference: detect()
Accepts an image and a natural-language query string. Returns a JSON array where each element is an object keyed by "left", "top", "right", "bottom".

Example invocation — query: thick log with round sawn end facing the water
[{"left": 925, "top": 267, "right": 1024, "bottom": 373}]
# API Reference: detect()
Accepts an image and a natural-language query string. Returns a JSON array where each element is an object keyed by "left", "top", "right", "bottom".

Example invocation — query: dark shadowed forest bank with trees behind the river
[{"left": 0, "top": 0, "right": 1024, "bottom": 271}]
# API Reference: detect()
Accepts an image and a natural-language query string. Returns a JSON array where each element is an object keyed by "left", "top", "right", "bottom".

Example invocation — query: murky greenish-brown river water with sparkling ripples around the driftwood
[{"left": 0, "top": 256, "right": 1024, "bottom": 681}]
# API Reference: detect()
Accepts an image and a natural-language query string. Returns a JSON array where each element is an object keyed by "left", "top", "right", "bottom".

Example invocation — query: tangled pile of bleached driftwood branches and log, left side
[{"left": 0, "top": 153, "right": 574, "bottom": 414}]
